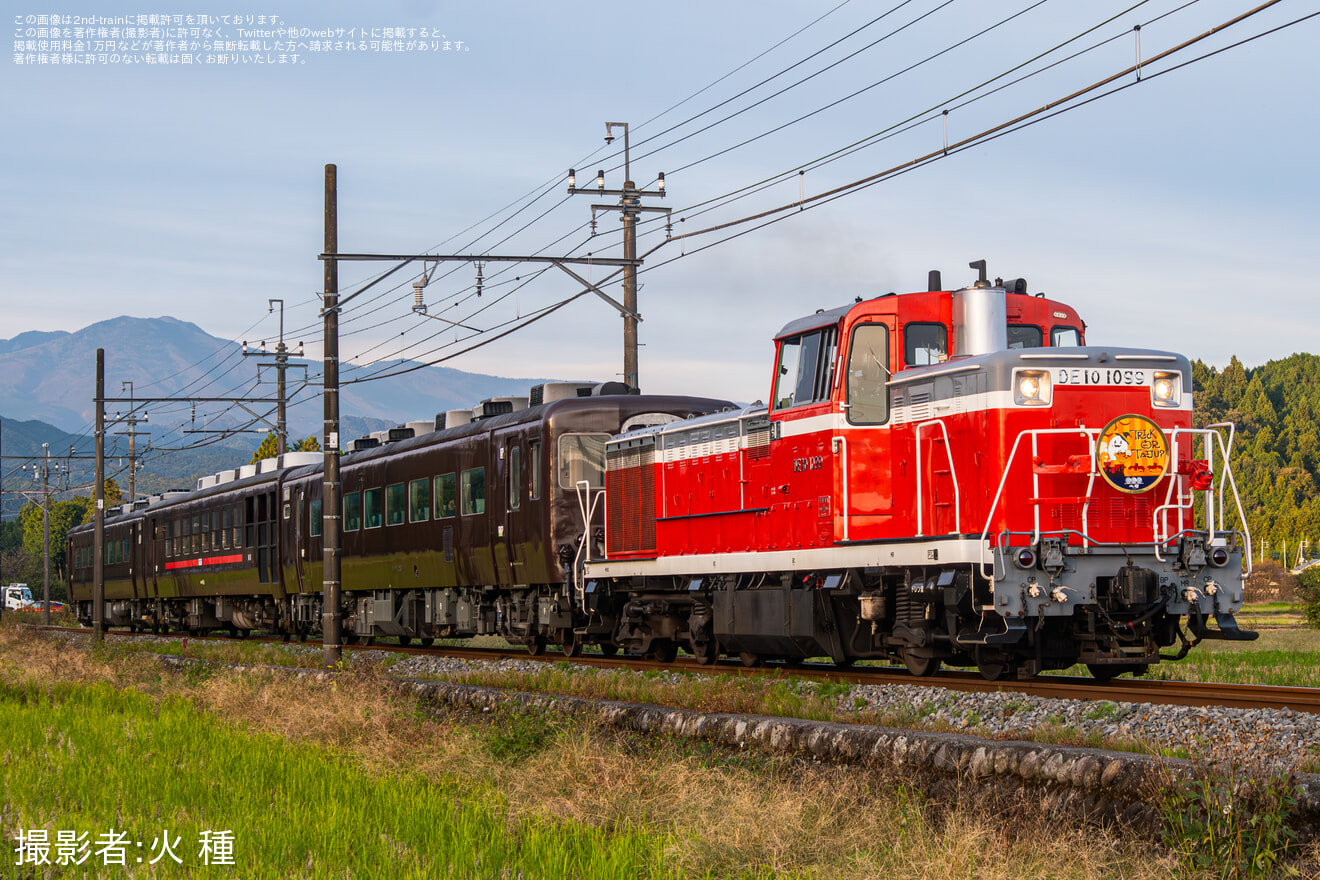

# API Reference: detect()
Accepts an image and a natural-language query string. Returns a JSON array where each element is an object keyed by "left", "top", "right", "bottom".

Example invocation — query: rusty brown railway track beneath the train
[{"left": 23, "top": 625, "right": 1320, "bottom": 714}]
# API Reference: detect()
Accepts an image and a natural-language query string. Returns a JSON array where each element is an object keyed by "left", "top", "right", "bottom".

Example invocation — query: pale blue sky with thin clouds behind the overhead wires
[{"left": 0, "top": 0, "right": 1320, "bottom": 401}]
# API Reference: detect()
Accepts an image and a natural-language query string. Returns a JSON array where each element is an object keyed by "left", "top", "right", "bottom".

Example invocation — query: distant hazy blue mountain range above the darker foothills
[{"left": 0, "top": 317, "right": 543, "bottom": 441}]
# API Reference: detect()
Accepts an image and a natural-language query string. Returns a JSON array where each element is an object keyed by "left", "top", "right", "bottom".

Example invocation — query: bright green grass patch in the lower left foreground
[{"left": 0, "top": 685, "right": 667, "bottom": 880}]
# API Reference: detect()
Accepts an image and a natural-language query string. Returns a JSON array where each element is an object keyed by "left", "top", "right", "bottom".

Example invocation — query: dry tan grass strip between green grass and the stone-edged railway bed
[{"left": 0, "top": 627, "right": 1267, "bottom": 880}]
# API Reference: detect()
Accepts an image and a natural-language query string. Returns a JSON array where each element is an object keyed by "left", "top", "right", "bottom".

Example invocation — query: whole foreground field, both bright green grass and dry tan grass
[{"left": 0, "top": 627, "right": 1309, "bottom": 880}]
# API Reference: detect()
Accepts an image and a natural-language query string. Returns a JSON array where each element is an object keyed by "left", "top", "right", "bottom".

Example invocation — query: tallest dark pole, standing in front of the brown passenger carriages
[{"left": 321, "top": 165, "right": 343, "bottom": 669}]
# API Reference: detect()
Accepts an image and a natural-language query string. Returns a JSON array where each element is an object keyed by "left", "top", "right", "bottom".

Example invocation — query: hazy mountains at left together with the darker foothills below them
[{"left": 0, "top": 317, "right": 557, "bottom": 517}]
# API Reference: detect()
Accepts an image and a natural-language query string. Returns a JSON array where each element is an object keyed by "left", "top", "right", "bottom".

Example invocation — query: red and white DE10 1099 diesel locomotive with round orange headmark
[{"left": 591, "top": 261, "right": 1255, "bottom": 679}]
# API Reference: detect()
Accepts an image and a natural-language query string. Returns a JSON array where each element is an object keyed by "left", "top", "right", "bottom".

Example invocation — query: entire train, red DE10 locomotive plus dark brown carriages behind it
[{"left": 67, "top": 261, "right": 1255, "bottom": 679}]
